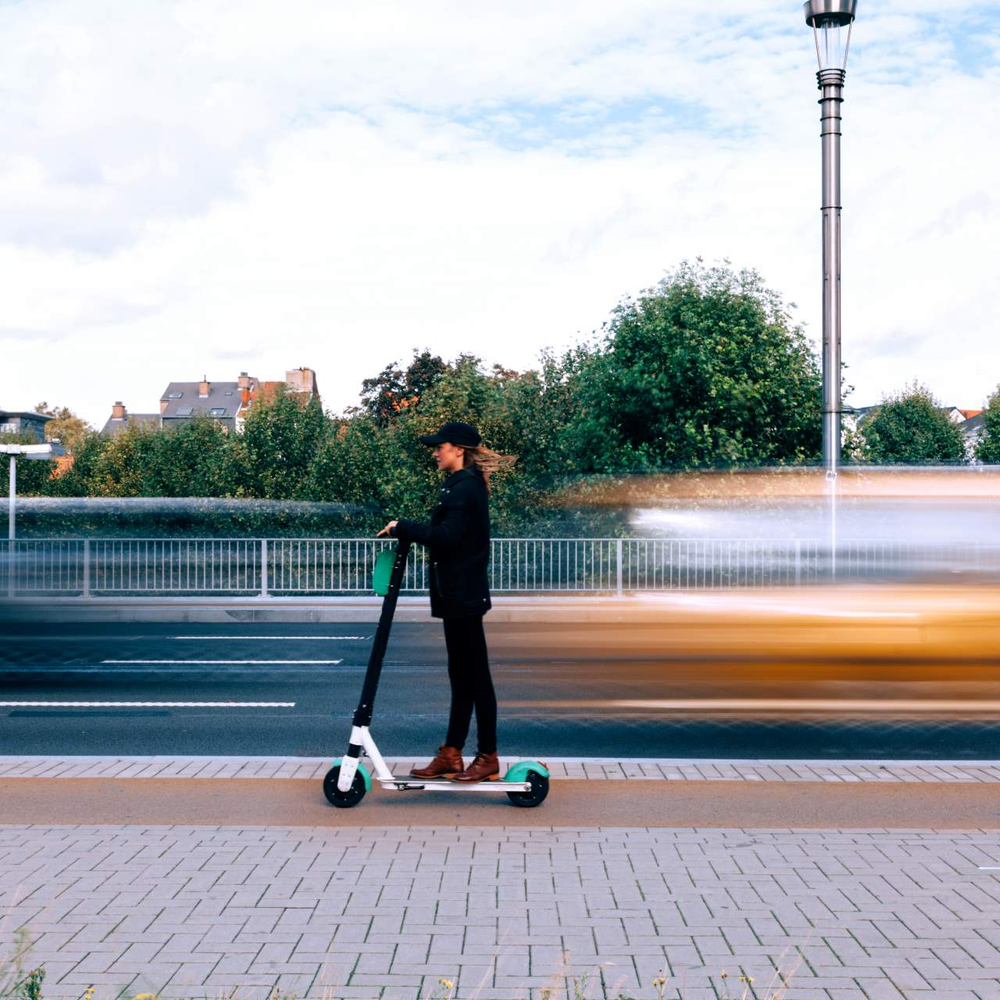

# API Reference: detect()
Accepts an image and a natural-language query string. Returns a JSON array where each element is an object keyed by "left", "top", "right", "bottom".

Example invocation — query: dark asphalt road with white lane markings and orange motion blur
[{"left": 0, "top": 619, "right": 1000, "bottom": 759}]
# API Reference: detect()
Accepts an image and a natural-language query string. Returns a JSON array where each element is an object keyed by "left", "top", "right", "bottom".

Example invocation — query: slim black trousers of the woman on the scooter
[{"left": 444, "top": 615, "right": 497, "bottom": 753}]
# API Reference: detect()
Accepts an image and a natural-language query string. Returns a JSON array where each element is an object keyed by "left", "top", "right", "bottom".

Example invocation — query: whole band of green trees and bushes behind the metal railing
[{"left": 0, "top": 261, "right": 1000, "bottom": 536}]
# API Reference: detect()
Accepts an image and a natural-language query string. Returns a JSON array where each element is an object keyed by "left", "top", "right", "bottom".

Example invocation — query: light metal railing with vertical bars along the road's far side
[{"left": 0, "top": 538, "right": 1000, "bottom": 598}]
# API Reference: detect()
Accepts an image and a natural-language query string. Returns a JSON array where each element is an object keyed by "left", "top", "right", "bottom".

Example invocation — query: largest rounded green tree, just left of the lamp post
[{"left": 563, "top": 261, "right": 821, "bottom": 472}]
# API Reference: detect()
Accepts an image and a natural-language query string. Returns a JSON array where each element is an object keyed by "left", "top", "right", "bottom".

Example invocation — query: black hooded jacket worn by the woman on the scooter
[{"left": 393, "top": 469, "right": 490, "bottom": 618}]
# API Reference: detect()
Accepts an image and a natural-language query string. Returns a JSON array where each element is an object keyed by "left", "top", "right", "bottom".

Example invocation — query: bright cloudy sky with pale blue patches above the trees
[{"left": 0, "top": 0, "right": 1000, "bottom": 427}]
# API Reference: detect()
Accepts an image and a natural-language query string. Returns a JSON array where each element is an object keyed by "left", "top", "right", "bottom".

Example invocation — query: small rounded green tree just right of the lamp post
[{"left": 860, "top": 382, "right": 965, "bottom": 465}]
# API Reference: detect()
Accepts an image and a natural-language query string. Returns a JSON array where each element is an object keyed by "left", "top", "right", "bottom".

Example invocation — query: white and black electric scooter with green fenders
[{"left": 323, "top": 542, "right": 549, "bottom": 809}]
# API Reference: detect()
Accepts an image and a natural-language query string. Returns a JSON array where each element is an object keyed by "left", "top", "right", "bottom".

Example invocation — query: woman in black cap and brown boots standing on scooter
[{"left": 379, "top": 421, "right": 513, "bottom": 782}]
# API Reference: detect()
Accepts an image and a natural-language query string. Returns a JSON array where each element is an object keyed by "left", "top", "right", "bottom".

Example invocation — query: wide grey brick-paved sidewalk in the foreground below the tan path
[{"left": 0, "top": 826, "right": 1000, "bottom": 1000}]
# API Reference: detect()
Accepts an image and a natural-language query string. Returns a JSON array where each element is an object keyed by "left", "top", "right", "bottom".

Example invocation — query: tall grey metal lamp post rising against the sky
[{"left": 803, "top": 0, "right": 858, "bottom": 479}]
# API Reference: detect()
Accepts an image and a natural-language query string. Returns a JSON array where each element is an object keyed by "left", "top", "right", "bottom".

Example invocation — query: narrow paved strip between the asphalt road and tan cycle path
[{"left": 0, "top": 756, "right": 1000, "bottom": 782}]
